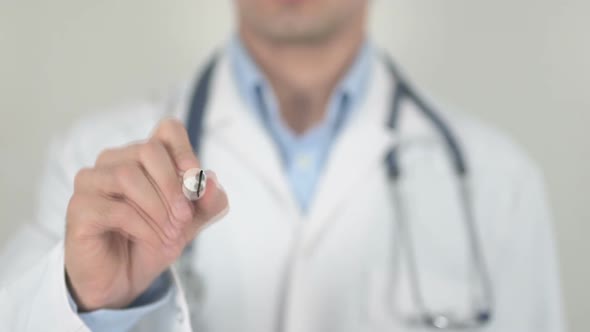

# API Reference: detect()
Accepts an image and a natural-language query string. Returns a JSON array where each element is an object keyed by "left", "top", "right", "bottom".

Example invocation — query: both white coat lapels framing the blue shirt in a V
[{"left": 169, "top": 49, "right": 442, "bottom": 252}]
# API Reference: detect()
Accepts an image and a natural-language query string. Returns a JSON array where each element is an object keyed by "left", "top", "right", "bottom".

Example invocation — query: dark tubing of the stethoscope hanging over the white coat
[{"left": 185, "top": 52, "right": 493, "bottom": 329}]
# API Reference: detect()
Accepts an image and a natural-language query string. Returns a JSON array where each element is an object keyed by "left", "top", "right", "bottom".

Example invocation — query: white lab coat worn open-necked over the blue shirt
[{"left": 0, "top": 50, "right": 564, "bottom": 332}]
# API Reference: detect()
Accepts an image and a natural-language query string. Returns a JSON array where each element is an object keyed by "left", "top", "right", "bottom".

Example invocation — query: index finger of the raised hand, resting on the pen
[{"left": 151, "top": 119, "right": 201, "bottom": 173}]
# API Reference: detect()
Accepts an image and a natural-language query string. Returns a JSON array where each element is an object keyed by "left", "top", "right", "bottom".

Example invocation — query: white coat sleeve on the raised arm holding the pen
[{"left": 0, "top": 122, "right": 197, "bottom": 332}]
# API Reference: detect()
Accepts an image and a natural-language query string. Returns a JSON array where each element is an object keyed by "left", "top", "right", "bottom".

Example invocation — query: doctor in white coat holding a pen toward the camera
[{"left": 0, "top": 0, "right": 564, "bottom": 332}]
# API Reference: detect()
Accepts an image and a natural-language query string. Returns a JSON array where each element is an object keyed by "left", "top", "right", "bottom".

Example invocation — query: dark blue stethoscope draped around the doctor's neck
[{"left": 179, "top": 52, "right": 493, "bottom": 331}]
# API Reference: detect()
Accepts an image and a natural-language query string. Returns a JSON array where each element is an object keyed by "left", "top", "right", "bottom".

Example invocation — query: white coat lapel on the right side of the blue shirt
[{"left": 302, "top": 59, "right": 395, "bottom": 250}]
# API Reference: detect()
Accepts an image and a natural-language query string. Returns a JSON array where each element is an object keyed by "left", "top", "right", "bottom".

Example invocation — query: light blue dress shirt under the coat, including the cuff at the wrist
[{"left": 70, "top": 36, "right": 373, "bottom": 332}]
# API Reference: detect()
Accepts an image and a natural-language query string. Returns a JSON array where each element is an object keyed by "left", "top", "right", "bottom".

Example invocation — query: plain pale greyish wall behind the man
[{"left": 0, "top": 0, "right": 590, "bottom": 331}]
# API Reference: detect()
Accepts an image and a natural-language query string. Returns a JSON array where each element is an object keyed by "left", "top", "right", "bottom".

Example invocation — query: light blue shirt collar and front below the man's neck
[{"left": 229, "top": 37, "right": 372, "bottom": 213}]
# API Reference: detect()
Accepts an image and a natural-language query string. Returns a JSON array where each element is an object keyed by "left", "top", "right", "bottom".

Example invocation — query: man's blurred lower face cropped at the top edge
[{"left": 235, "top": 0, "right": 369, "bottom": 43}]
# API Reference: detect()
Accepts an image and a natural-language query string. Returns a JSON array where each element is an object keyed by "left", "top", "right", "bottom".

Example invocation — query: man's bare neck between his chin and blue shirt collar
[{"left": 240, "top": 18, "right": 365, "bottom": 134}]
